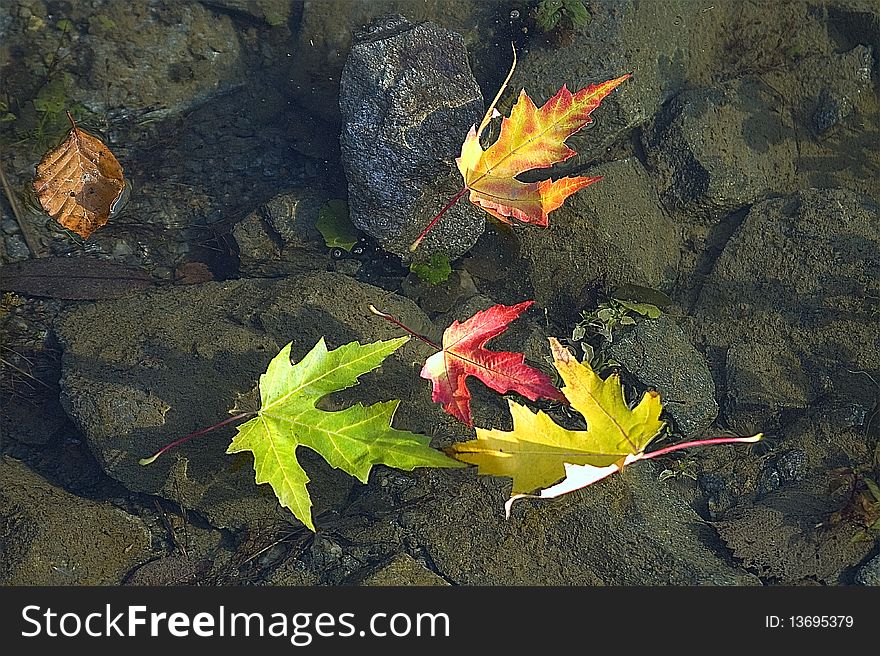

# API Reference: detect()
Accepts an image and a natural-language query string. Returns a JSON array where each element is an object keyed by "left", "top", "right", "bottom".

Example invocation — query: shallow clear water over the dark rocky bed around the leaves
[{"left": 0, "top": 0, "right": 880, "bottom": 585}]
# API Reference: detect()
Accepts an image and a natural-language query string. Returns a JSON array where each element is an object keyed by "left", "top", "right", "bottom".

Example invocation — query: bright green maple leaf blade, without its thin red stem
[{"left": 226, "top": 337, "right": 463, "bottom": 531}]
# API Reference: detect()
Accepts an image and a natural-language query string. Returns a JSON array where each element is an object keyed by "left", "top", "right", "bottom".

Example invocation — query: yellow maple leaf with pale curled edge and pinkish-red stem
[{"left": 447, "top": 337, "right": 762, "bottom": 516}]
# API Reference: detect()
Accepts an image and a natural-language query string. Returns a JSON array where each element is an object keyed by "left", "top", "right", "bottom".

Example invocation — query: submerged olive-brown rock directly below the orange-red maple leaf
[{"left": 521, "top": 158, "right": 681, "bottom": 320}]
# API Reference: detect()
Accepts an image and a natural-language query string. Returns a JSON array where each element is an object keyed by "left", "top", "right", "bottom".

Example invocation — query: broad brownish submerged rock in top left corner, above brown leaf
[{"left": 0, "top": 0, "right": 243, "bottom": 120}]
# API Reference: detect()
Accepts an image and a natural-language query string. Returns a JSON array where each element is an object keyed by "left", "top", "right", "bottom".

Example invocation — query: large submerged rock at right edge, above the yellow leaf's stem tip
[{"left": 695, "top": 189, "right": 880, "bottom": 420}]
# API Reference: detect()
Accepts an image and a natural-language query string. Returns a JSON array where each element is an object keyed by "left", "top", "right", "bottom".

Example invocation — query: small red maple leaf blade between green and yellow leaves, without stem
[{"left": 420, "top": 301, "right": 565, "bottom": 426}]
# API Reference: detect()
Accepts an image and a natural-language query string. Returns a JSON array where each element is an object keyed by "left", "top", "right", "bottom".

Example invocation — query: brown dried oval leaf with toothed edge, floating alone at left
[{"left": 34, "top": 114, "right": 125, "bottom": 239}]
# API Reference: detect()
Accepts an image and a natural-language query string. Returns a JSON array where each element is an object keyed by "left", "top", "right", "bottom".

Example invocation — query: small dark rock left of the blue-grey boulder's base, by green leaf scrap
[{"left": 232, "top": 188, "right": 329, "bottom": 278}]
